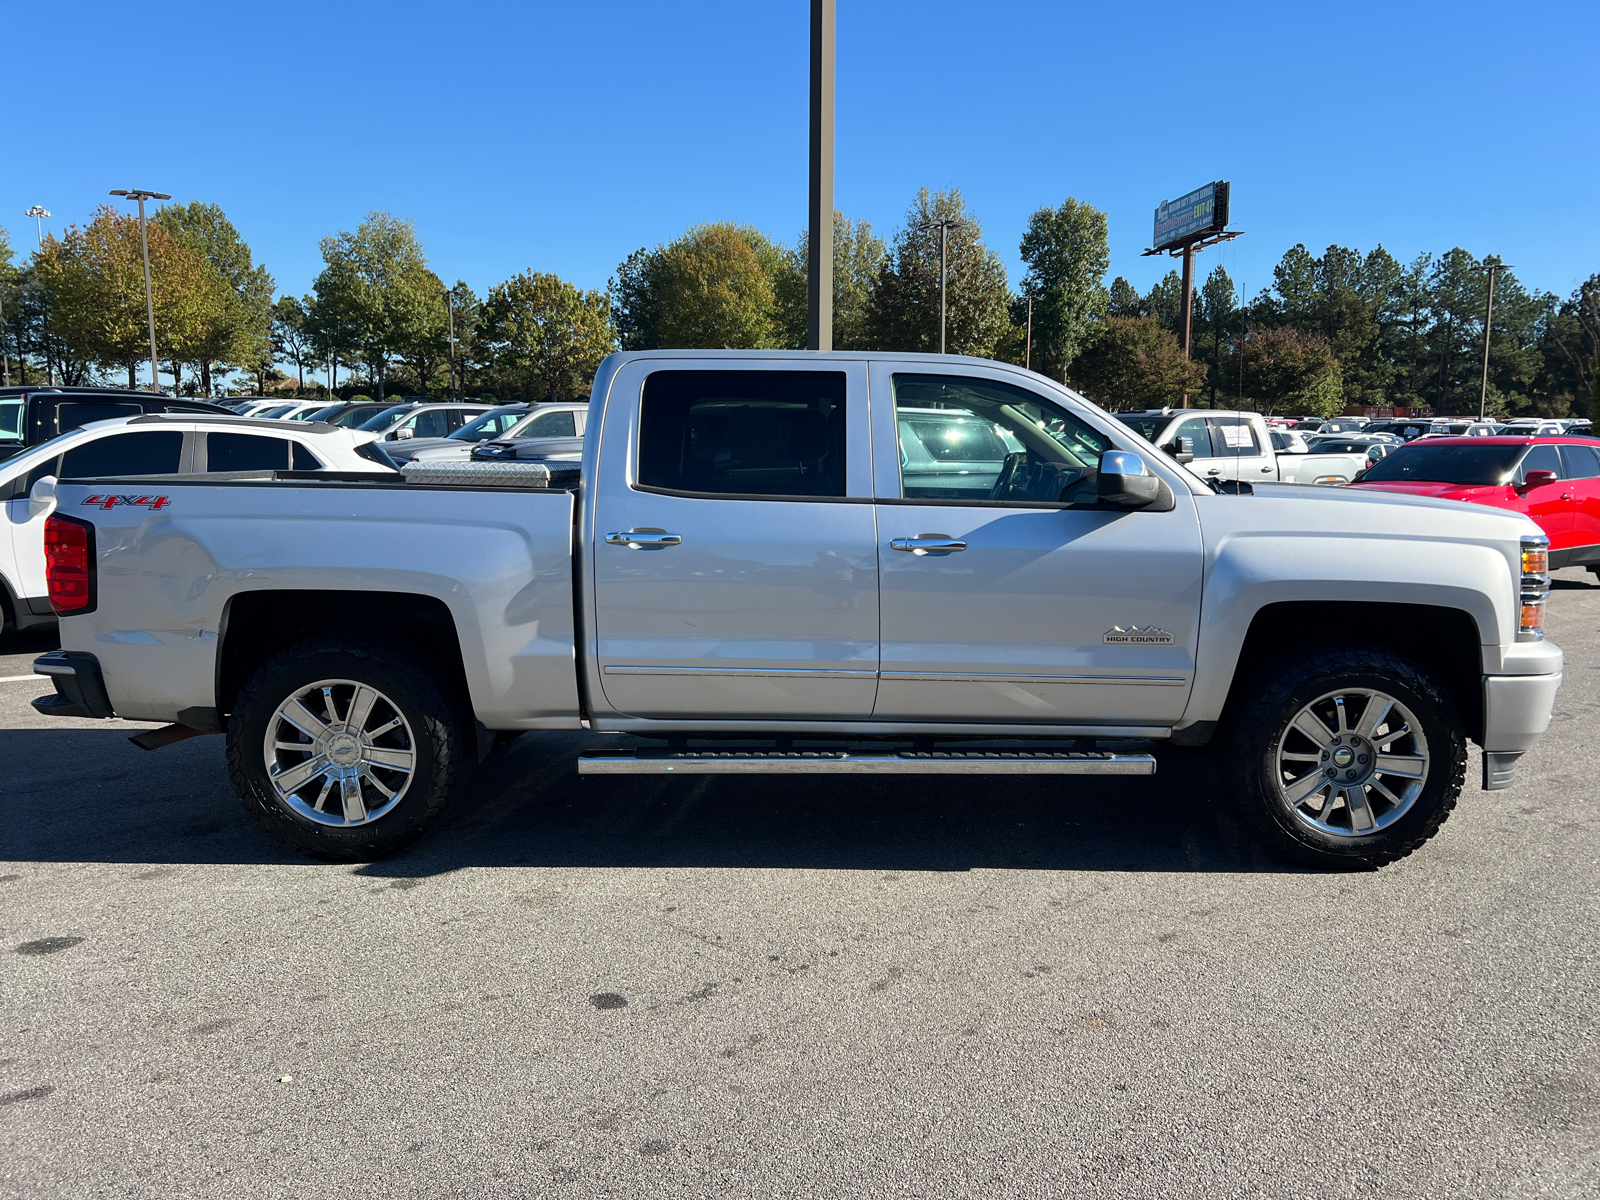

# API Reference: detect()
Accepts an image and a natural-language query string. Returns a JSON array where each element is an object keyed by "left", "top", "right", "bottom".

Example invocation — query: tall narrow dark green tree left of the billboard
[{"left": 1021, "top": 197, "right": 1110, "bottom": 381}]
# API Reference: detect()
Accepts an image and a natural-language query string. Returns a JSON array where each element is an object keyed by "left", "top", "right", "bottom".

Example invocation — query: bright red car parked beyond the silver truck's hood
[{"left": 1349, "top": 437, "right": 1600, "bottom": 574}]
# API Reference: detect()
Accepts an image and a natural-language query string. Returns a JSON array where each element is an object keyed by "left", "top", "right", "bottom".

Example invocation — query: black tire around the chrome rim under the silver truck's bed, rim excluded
[{"left": 227, "top": 637, "right": 472, "bottom": 862}]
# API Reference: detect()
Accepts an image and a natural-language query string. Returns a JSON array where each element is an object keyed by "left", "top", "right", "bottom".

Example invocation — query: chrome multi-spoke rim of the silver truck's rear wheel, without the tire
[{"left": 264, "top": 678, "right": 416, "bottom": 826}]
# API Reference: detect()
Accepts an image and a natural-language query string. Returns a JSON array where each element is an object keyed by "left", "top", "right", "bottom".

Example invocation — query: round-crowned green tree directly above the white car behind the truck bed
[{"left": 312, "top": 213, "right": 445, "bottom": 400}]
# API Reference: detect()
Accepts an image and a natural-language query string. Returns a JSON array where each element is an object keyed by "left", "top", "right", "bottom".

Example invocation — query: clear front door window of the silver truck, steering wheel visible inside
[{"left": 894, "top": 374, "right": 1110, "bottom": 504}]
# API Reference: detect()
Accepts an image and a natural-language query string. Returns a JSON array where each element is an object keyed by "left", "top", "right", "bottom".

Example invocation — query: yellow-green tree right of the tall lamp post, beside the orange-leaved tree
[{"left": 150, "top": 200, "right": 274, "bottom": 395}]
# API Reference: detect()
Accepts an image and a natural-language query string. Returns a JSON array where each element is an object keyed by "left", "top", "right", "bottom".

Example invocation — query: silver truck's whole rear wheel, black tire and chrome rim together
[{"left": 227, "top": 637, "right": 467, "bottom": 861}]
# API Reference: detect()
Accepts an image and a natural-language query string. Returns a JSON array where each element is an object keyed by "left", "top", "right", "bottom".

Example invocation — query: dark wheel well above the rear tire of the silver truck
[{"left": 216, "top": 590, "right": 472, "bottom": 728}]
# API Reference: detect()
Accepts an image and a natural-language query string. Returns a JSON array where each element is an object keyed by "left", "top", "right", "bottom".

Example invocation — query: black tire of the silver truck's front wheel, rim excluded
[{"left": 1219, "top": 646, "right": 1467, "bottom": 870}]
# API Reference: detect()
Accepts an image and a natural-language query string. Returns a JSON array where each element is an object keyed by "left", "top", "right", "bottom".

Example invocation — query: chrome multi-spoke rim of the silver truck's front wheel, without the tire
[{"left": 1277, "top": 688, "right": 1429, "bottom": 838}]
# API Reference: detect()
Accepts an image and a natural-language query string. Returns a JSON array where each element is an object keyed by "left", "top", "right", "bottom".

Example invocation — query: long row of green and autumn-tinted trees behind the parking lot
[{"left": 0, "top": 189, "right": 1600, "bottom": 416}]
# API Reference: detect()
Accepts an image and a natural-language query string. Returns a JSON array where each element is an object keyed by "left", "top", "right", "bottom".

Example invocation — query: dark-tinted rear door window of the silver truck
[{"left": 638, "top": 371, "right": 845, "bottom": 496}]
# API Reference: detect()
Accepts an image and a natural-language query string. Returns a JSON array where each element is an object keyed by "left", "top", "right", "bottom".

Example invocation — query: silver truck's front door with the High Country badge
[{"left": 872, "top": 363, "right": 1203, "bottom": 725}]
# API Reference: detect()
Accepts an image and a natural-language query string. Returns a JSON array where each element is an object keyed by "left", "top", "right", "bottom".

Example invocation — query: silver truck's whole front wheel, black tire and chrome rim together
[{"left": 1224, "top": 648, "right": 1467, "bottom": 867}]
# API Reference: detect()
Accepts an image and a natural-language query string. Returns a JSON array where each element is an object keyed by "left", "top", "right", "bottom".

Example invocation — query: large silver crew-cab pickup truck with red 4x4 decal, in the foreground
[{"left": 29, "top": 350, "right": 1562, "bottom": 866}]
